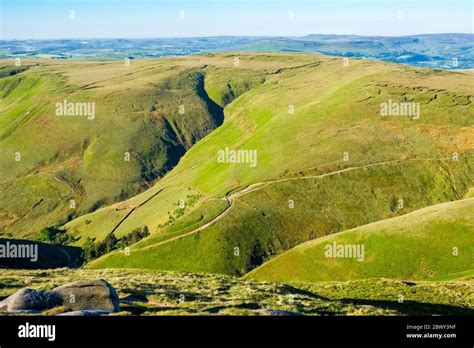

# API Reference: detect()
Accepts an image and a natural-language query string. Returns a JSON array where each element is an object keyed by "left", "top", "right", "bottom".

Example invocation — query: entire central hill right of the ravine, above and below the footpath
[{"left": 83, "top": 54, "right": 474, "bottom": 274}]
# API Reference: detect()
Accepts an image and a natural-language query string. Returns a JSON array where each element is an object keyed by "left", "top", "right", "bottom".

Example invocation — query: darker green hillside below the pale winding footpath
[{"left": 90, "top": 160, "right": 472, "bottom": 276}]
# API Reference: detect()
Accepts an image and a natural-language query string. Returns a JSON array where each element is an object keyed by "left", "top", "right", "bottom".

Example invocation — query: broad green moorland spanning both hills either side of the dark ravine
[{"left": 0, "top": 53, "right": 474, "bottom": 275}]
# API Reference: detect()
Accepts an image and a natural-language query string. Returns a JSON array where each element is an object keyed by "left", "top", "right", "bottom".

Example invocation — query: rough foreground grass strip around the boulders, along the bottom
[{"left": 0, "top": 269, "right": 474, "bottom": 315}]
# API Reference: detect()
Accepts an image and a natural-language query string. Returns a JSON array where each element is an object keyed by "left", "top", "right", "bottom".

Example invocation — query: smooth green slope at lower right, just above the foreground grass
[{"left": 248, "top": 198, "right": 474, "bottom": 282}]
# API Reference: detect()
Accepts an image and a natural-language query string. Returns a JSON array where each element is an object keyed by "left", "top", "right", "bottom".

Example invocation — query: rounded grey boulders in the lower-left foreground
[{"left": 0, "top": 279, "right": 120, "bottom": 312}]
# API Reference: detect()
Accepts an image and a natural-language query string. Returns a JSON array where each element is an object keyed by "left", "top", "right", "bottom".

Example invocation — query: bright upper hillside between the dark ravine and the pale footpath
[{"left": 64, "top": 55, "right": 473, "bottom": 250}]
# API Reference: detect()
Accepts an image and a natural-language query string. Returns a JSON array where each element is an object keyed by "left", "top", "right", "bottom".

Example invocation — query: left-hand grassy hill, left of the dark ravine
[{"left": 0, "top": 60, "right": 236, "bottom": 237}]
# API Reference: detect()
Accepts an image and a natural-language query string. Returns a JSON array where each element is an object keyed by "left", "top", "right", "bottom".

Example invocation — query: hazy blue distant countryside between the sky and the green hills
[{"left": 0, "top": 34, "right": 474, "bottom": 69}]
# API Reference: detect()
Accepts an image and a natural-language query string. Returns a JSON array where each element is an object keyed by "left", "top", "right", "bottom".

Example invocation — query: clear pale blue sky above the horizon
[{"left": 0, "top": 0, "right": 474, "bottom": 40}]
